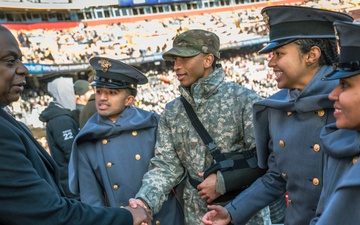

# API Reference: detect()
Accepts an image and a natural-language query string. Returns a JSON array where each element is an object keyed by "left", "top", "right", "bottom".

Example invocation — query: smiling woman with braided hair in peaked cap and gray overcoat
[{"left": 203, "top": 6, "right": 353, "bottom": 225}]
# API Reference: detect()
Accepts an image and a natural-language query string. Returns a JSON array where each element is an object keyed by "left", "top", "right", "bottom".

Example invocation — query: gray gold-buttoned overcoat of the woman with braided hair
[{"left": 226, "top": 66, "right": 338, "bottom": 225}]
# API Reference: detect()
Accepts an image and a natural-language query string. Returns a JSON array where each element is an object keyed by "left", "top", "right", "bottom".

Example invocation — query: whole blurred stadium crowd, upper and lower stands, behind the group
[{"left": 6, "top": 1, "right": 358, "bottom": 144}]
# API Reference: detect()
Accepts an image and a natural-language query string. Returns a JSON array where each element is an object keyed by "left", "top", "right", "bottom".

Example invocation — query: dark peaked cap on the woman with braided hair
[{"left": 258, "top": 6, "right": 353, "bottom": 54}]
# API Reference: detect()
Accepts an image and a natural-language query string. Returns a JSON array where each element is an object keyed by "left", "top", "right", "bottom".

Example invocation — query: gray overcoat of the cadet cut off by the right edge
[{"left": 311, "top": 124, "right": 360, "bottom": 225}]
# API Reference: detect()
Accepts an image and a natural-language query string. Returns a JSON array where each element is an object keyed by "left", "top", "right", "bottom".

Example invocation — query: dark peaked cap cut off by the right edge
[{"left": 322, "top": 21, "right": 360, "bottom": 80}]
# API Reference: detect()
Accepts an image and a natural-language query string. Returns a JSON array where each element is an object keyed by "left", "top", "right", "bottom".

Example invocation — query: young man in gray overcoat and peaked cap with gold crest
[{"left": 69, "top": 57, "right": 183, "bottom": 225}]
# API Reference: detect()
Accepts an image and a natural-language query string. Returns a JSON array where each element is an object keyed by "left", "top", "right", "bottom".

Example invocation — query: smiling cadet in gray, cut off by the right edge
[{"left": 311, "top": 19, "right": 360, "bottom": 225}]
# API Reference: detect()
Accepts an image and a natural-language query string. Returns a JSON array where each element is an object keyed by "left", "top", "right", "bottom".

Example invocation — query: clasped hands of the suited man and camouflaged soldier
[{"left": 125, "top": 198, "right": 153, "bottom": 225}]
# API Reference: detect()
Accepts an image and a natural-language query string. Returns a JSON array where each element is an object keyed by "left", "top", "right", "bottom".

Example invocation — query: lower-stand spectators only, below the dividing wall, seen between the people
[{"left": 12, "top": 49, "right": 277, "bottom": 128}]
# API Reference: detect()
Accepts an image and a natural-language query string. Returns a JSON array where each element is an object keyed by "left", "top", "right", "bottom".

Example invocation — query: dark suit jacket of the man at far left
[{"left": 0, "top": 109, "right": 133, "bottom": 225}]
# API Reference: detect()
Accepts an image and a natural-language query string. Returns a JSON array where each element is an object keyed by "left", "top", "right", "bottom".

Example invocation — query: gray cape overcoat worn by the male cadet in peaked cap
[{"left": 69, "top": 106, "right": 183, "bottom": 225}]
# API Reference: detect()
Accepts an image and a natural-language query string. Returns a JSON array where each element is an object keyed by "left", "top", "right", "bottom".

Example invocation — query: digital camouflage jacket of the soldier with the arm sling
[{"left": 136, "top": 68, "right": 270, "bottom": 225}]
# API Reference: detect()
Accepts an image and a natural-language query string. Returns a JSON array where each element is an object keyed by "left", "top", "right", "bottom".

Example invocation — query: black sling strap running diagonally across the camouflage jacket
[{"left": 180, "top": 95, "right": 225, "bottom": 162}]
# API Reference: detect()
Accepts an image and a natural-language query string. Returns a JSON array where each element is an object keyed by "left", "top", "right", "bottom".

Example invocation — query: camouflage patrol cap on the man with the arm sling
[{"left": 163, "top": 29, "right": 220, "bottom": 61}]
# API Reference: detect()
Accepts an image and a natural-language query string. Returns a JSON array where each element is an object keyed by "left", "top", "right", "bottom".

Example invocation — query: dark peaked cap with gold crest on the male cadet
[{"left": 90, "top": 57, "right": 148, "bottom": 89}]
